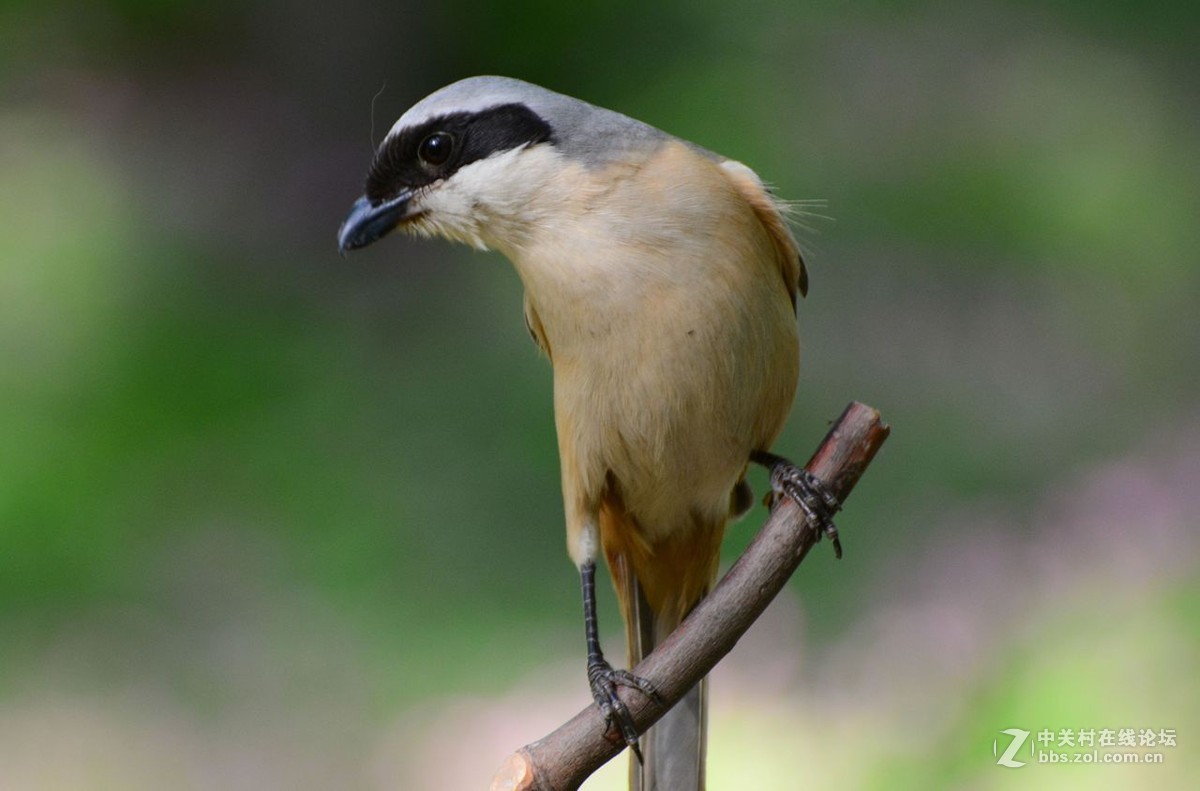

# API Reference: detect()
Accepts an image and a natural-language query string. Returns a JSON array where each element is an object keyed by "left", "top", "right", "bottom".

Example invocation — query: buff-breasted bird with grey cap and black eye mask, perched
[{"left": 337, "top": 76, "right": 841, "bottom": 791}]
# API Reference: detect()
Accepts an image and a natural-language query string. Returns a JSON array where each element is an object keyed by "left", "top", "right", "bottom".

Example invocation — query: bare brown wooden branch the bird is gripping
[{"left": 491, "top": 401, "right": 890, "bottom": 791}]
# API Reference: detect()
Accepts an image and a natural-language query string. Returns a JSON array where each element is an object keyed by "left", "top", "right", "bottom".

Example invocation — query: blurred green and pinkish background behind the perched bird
[{"left": 0, "top": 0, "right": 1200, "bottom": 790}]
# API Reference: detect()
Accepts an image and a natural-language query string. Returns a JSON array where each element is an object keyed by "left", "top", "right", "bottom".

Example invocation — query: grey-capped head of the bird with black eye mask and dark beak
[{"left": 337, "top": 77, "right": 667, "bottom": 252}]
